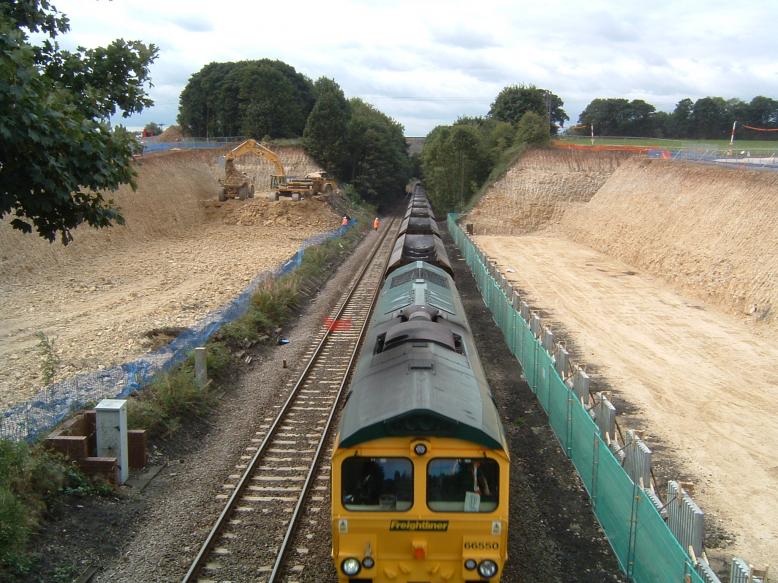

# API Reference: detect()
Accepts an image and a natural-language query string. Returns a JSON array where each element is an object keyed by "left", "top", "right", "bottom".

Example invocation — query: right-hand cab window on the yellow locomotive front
[{"left": 427, "top": 458, "right": 500, "bottom": 512}]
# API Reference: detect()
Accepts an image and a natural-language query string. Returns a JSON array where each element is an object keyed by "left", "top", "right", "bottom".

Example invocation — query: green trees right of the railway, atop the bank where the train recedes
[{"left": 417, "top": 85, "right": 556, "bottom": 212}]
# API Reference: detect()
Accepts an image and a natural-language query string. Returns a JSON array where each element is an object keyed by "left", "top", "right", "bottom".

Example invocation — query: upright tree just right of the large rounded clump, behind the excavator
[{"left": 303, "top": 77, "right": 350, "bottom": 174}]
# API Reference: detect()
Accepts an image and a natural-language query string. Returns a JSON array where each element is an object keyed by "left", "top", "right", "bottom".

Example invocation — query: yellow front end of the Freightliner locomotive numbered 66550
[{"left": 332, "top": 437, "right": 509, "bottom": 583}]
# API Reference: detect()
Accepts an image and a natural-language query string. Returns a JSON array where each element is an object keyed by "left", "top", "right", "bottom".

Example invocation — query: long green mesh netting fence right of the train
[{"left": 448, "top": 213, "right": 703, "bottom": 583}]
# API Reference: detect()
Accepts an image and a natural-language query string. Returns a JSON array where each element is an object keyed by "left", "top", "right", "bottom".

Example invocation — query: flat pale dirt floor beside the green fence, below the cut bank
[{"left": 475, "top": 235, "right": 778, "bottom": 565}]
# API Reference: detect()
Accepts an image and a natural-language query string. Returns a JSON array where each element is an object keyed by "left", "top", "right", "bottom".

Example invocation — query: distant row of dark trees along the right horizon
[{"left": 570, "top": 95, "right": 778, "bottom": 140}]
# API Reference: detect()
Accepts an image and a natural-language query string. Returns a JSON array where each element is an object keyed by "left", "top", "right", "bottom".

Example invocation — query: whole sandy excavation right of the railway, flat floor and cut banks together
[{"left": 464, "top": 152, "right": 778, "bottom": 565}]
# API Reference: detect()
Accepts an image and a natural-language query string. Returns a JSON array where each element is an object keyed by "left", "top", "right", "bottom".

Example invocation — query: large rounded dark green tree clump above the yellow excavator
[{"left": 178, "top": 59, "right": 316, "bottom": 139}]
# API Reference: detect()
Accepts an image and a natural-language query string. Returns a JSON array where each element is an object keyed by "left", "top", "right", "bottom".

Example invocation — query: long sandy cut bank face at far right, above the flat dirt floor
[{"left": 560, "top": 159, "right": 778, "bottom": 324}]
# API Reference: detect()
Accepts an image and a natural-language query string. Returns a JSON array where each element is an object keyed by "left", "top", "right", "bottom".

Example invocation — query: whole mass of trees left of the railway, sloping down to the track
[{"left": 178, "top": 59, "right": 409, "bottom": 204}]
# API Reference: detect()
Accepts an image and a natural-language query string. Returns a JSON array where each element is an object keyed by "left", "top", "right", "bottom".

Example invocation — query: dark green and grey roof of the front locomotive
[{"left": 339, "top": 262, "right": 505, "bottom": 449}]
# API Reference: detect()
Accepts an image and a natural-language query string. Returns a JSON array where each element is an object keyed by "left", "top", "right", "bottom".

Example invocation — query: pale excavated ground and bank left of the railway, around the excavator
[{"left": 0, "top": 149, "right": 340, "bottom": 410}]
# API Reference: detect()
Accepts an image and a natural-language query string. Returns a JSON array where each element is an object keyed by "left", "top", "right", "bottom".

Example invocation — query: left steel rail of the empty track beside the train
[{"left": 181, "top": 221, "right": 394, "bottom": 583}]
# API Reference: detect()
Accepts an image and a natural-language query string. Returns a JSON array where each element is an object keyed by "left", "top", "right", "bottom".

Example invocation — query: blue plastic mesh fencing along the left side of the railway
[{"left": 0, "top": 219, "right": 356, "bottom": 441}]
